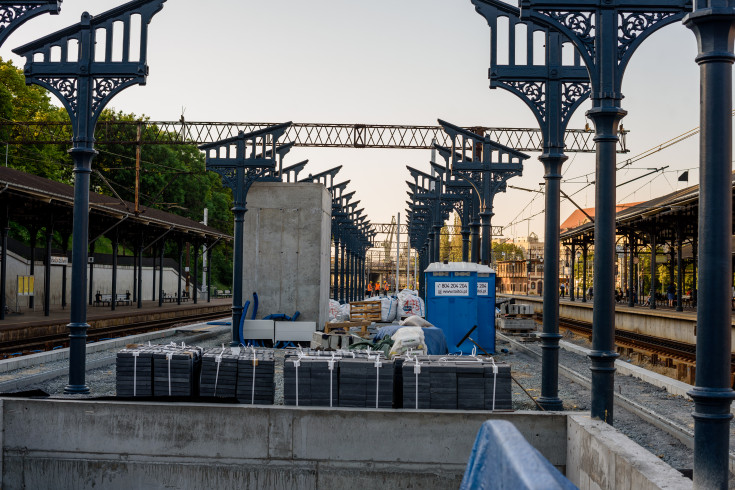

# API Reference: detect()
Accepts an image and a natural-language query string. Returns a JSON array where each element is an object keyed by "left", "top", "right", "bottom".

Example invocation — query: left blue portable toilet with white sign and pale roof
[{"left": 424, "top": 262, "right": 479, "bottom": 354}]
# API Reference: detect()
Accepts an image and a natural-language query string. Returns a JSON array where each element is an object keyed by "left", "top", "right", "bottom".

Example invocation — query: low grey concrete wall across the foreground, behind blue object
[{"left": 0, "top": 399, "right": 567, "bottom": 489}]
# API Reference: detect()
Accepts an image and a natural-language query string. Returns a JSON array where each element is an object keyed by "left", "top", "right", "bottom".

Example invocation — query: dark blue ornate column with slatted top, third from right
[{"left": 473, "top": 0, "right": 590, "bottom": 410}]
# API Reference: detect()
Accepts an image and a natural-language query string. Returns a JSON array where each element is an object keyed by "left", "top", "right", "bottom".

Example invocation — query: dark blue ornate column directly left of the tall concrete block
[{"left": 203, "top": 122, "right": 291, "bottom": 346}]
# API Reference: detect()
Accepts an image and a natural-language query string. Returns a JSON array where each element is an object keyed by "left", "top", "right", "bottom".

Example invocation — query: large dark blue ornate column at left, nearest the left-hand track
[{"left": 13, "top": 0, "right": 166, "bottom": 394}]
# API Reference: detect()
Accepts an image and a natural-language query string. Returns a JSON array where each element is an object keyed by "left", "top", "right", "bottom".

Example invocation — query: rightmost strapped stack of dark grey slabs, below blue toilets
[{"left": 396, "top": 356, "right": 512, "bottom": 410}]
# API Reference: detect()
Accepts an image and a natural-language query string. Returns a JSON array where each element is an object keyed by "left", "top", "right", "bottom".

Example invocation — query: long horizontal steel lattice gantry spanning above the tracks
[{"left": 0, "top": 121, "right": 628, "bottom": 153}]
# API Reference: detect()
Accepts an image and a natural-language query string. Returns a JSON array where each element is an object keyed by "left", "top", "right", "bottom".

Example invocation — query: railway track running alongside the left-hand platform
[{"left": 0, "top": 307, "right": 230, "bottom": 359}]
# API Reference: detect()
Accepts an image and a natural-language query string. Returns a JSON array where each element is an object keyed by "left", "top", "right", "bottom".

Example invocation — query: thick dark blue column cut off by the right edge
[{"left": 684, "top": 0, "right": 735, "bottom": 488}]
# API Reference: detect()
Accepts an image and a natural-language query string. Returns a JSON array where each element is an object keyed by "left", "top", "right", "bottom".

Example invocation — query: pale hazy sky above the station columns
[{"left": 0, "top": 0, "right": 720, "bottom": 244}]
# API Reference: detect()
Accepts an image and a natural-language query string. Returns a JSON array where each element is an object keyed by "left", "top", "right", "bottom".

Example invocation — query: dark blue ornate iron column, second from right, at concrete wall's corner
[{"left": 521, "top": 0, "right": 691, "bottom": 424}]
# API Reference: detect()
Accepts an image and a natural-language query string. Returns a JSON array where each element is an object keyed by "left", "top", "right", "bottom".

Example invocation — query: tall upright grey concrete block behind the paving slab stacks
[{"left": 243, "top": 182, "right": 331, "bottom": 328}]
